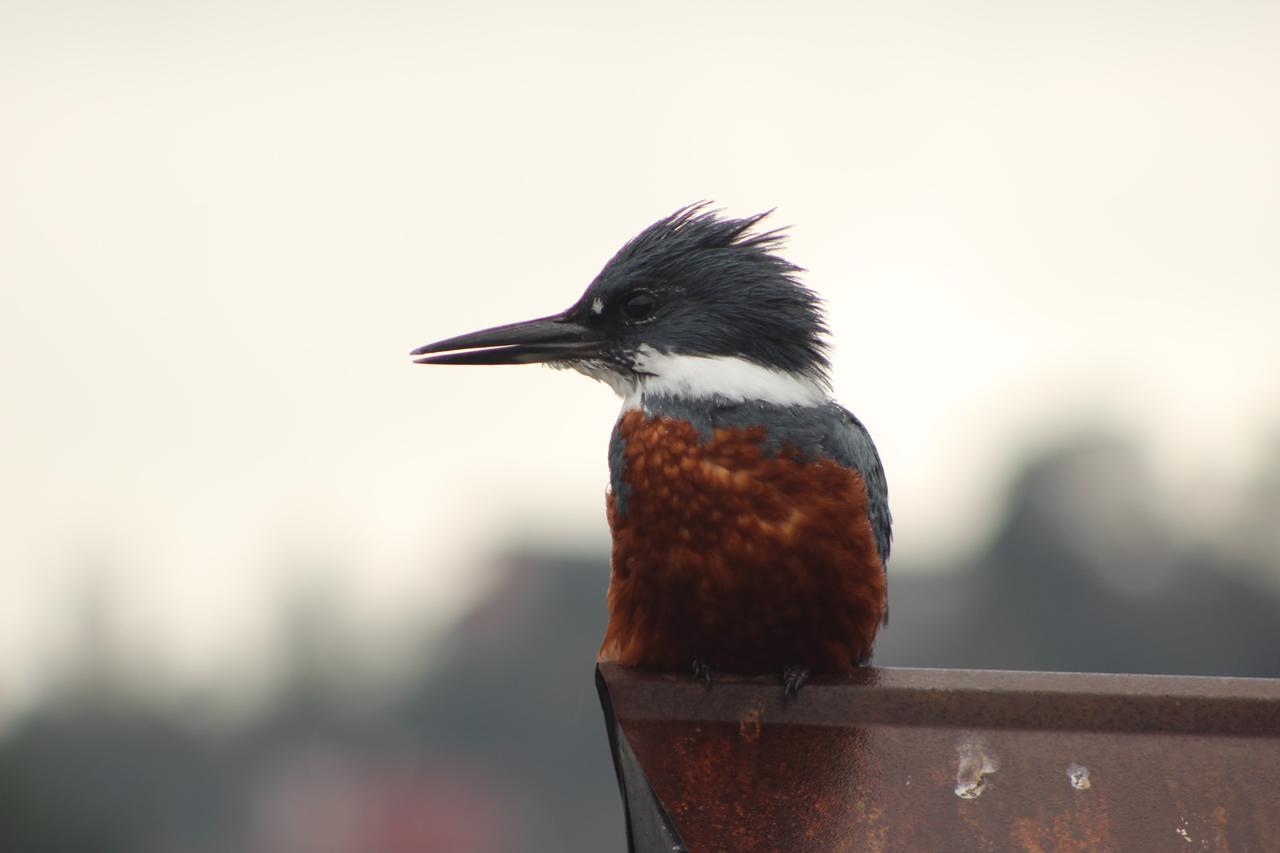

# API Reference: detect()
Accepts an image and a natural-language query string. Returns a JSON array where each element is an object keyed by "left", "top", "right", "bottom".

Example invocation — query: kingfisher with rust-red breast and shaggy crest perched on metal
[{"left": 412, "top": 202, "right": 892, "bottom": 695}]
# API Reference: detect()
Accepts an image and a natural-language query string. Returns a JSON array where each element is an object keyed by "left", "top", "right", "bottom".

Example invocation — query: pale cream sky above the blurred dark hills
[{"left": 0, "top": 0, "right": 1280, "bottom": 715}]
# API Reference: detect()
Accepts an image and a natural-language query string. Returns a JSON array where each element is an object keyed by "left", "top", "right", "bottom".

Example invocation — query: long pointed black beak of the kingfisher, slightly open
[{"left": 410, "top": 314, "right": 602, "bottom": 364}]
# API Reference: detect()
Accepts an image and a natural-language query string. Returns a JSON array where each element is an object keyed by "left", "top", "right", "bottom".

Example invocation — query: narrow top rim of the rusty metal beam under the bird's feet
[{"left": 598, "top": 663, "right": 1280, "bottom": 736}]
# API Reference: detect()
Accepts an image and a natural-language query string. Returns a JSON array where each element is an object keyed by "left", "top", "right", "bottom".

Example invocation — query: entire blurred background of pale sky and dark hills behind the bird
[{"left": 0, "top": 0, "right": 1280, "bottom": 853}]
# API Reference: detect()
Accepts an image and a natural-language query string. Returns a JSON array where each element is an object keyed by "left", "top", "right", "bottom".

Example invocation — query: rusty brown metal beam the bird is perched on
[{"left": 600, "top": 663, "right": 1280, "bottom": 853}]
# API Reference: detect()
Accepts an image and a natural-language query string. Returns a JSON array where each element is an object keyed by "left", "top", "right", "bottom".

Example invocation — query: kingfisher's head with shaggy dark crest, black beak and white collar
[{"left": 413, "top": 204, "right": 827, "bottom": 405}]
